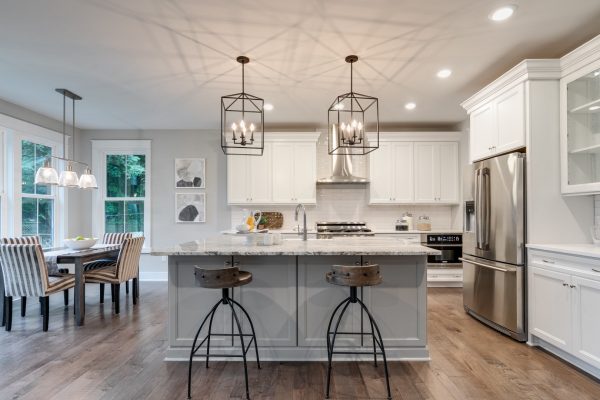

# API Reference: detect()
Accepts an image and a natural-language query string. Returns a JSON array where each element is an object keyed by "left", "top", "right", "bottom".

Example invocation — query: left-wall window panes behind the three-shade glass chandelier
[{"left": 21, "top": 140, "right": 55, "bottom": 248}]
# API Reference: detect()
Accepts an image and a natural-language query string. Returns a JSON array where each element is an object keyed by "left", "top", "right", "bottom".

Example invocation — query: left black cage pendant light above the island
[{"left": 221, "top": 56, "right": 265, "bottom": 156}]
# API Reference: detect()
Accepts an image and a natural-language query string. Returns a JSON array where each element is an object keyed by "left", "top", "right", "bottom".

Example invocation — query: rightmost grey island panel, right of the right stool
[{"left": 363, "top": 256, "right": 427, "bottom": 350}]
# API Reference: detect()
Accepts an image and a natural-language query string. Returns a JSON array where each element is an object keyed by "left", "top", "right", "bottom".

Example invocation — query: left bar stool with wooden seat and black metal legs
[{"left": 188, "top": 267, "right": 260, "bottom": 399}]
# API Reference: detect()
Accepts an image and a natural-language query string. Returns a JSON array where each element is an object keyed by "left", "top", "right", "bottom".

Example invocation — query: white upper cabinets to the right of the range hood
[{"left": 369, "top": 133, "right": 460, "bottom": 204}]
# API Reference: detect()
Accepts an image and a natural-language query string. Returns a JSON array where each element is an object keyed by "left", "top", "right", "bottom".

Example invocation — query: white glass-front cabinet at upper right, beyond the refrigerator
[{"left": 560, "top": 60, "right": 600, "bottom": 195}]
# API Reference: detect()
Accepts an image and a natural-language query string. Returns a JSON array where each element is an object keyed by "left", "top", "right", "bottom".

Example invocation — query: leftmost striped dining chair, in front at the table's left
[{"left": 0, "top": 244, "right": 75, "bottom": 332}]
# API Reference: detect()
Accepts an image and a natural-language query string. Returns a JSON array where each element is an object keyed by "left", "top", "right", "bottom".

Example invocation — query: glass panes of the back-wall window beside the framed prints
[{"left": 104, "top": 154, "right": 146, "bottom": 236}]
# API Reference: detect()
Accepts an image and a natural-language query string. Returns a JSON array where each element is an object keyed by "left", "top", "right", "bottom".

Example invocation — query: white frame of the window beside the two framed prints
[{"left": 91, "top": 139, "right": 152, "bottom": 248}]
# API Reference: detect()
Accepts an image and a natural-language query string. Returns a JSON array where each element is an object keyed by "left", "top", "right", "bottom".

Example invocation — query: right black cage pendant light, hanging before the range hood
[{"left": 327, "top": 55, "right": 379, "bottom": 155}]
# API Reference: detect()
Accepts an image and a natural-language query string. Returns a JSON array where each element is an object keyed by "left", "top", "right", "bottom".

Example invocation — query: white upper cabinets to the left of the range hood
[{"left": 227, "top": 133, "right": 319, "bottom": 205}]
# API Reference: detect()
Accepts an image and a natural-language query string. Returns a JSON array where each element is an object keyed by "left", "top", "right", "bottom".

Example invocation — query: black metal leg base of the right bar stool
[{"left": 325, "top": 286, "right": 392, "bottom": 399}]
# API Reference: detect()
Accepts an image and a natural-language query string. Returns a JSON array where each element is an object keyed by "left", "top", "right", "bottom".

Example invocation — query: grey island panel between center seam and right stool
[{"left": 298, "top": 255, "right": 361, "bottom": 346}]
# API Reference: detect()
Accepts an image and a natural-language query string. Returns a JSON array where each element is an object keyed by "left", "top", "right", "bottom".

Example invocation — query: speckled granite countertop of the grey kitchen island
[{"left": 151, "top": 236, "right": 441, "bottom": 256}]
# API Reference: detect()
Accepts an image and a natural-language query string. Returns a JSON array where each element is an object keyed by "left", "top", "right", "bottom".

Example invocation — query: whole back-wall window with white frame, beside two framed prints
[{"left": 92, "top": 140, "right": 151, "bottom": 248}]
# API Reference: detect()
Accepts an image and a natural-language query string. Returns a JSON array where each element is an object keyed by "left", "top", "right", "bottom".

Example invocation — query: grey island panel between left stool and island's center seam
[{"left": 233, "top": 256, "right": 297, "bottom": 346}]
